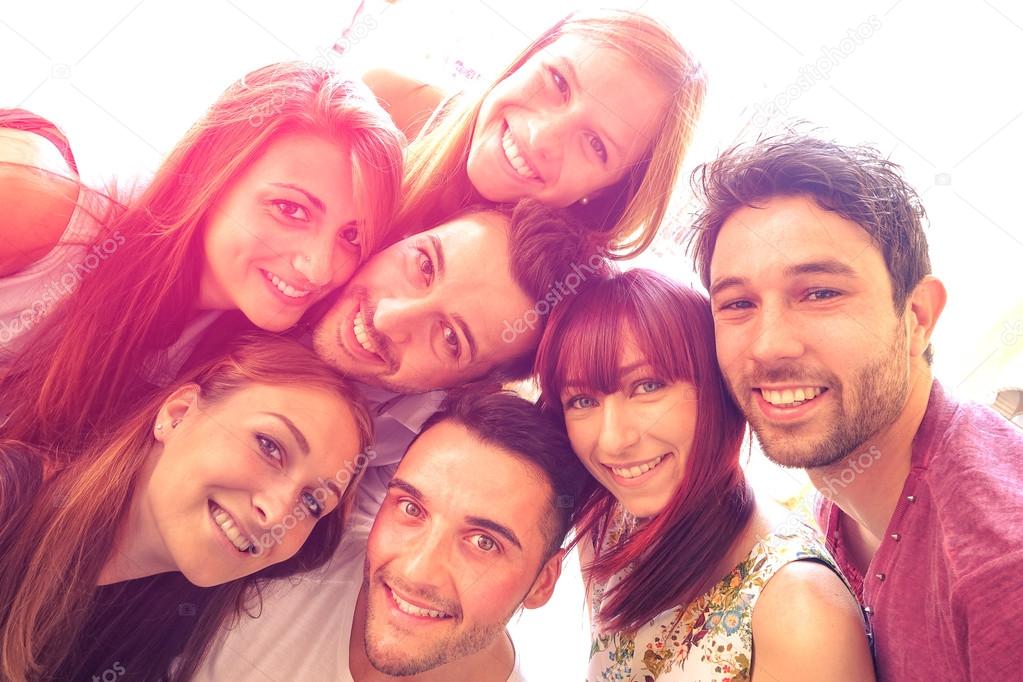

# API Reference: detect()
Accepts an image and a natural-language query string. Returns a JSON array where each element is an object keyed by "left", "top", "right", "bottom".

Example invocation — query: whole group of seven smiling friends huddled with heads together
[{"left": 0, "top": 10, "right": 1023, "bottom": 682}]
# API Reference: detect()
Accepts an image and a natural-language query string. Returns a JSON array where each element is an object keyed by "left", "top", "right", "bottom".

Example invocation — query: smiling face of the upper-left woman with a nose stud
[{"left": 199, "top": 133, "right": 364, "bottom": 331}]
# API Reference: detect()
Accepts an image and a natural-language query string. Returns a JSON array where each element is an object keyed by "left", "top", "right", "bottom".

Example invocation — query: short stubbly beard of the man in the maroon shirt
[{"left": 728, "top": 321, "right": 909, "bottom": 468}]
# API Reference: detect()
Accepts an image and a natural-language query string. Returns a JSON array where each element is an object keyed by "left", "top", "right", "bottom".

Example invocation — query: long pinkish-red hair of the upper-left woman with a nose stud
[{"left": 0, "top": 62, "right": 403, "bottom": 455}]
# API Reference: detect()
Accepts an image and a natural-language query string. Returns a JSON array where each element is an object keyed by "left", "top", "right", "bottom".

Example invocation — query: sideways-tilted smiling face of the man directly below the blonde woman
[{"left": 313, "top": 213, "right": 539, "bottom": 393}]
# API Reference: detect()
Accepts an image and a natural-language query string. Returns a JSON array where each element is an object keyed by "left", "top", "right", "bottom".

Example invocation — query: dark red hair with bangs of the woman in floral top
[{"left": 536, "top": 269, "right": 753, "bottom": 632}]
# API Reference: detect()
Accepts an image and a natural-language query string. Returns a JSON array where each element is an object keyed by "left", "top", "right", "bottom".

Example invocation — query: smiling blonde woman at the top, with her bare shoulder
[{"left": 364, "top": 10, "right": 706, "bottom": 258}]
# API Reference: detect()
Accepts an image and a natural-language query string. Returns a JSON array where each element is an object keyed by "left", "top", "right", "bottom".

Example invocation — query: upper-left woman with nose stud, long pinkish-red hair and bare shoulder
[{"left": 0, "top": 62, "right": 403, "bottom": 453}]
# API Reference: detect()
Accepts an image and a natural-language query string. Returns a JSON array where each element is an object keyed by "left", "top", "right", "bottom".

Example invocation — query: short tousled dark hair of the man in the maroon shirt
[{"left": 688, "top": 133, "right": 931, "bottom": 363}]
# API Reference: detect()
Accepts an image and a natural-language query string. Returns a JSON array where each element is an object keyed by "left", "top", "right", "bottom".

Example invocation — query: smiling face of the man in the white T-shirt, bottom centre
[{"left": 363, "top": 420, "right": 561, "bottom": 679}]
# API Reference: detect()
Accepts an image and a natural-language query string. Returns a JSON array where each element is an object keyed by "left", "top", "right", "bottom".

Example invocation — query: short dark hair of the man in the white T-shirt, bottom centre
[{"left": 409, "top": 388, "right": 590, "bottom": 561}]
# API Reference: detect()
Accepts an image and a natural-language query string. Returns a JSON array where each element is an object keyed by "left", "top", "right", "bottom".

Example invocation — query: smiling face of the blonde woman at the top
[{"left": 466, "top": 36, "right": 668, "bottom": 208}]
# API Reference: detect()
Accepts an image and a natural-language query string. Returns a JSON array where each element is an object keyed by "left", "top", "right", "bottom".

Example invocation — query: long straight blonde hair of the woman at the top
[{"left": 391, "top": 10, "right": 707, "bottom": 259}]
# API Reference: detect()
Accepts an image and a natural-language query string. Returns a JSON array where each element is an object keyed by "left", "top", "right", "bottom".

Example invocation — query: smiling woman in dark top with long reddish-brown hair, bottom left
[{"left": 0, "top": 336, "right": 371, "bottom": 682}]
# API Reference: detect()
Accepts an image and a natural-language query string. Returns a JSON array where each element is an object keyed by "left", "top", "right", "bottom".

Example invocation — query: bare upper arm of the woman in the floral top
[{"left": 753, "top": 561, "right": 875, "bottom": 682}]
